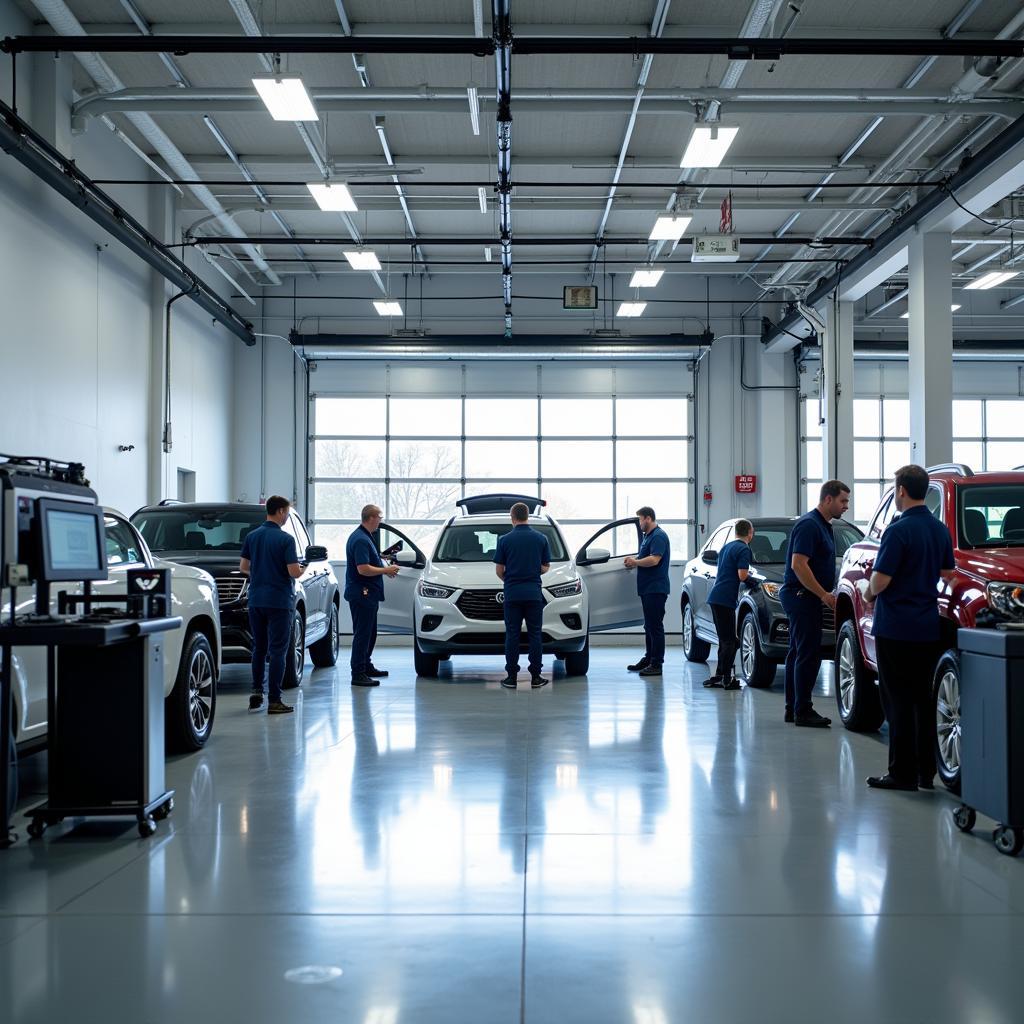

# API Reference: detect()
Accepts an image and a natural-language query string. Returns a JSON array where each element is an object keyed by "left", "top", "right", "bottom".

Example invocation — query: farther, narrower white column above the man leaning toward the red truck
[{"left": 821, "top": 302, "right": 854, "bottom": 509}]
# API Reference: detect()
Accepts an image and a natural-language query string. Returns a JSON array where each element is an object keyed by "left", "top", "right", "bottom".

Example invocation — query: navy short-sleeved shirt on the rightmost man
[{"left": 871, "top": 505, "right": 955, "bottom": 643}]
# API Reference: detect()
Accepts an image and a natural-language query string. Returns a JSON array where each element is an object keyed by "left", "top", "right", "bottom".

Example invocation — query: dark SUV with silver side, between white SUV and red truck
[{"left": 680, "top": 516, "right": 864, "bottom": 687}]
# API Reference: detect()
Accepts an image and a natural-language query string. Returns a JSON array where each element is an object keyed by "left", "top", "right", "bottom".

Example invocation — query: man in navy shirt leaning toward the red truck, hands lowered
[{"left": 778, "top": 480, "right": 850, "bottom": 729}]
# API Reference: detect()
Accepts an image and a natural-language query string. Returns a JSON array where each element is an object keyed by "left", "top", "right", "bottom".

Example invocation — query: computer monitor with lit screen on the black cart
[{"left": 36, "top": 498, "right": 106, "bottom": 583}]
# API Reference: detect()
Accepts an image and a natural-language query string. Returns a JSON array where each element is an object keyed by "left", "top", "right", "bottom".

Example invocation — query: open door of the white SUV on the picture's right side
[{"left": 575, "top": 516, "right": 643, "bottom": 633}]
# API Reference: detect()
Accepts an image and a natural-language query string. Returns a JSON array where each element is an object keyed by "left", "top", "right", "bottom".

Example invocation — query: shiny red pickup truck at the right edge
[{"left": 835, "top": 465, "right": 1024, "bottom": 793}]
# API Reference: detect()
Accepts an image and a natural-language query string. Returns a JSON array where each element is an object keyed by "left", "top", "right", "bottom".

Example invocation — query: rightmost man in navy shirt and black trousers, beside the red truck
[{"left": 864, "top": 466, "right": 955, "bottom": 791}]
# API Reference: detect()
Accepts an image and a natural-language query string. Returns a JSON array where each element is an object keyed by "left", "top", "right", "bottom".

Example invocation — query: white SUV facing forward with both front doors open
[{"left": 370, "top": 495, "right": 643, "bottom": 676}]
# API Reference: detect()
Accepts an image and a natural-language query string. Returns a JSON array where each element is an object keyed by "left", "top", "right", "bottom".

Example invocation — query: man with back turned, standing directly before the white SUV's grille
[{"left": 495, "top": 502, "right": 551, "bottom": 690}]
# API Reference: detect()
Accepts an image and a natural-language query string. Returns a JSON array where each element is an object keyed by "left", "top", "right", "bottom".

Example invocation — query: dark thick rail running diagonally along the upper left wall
[{"left": 0, "top": 101, "right": 256, "bottom": 345}]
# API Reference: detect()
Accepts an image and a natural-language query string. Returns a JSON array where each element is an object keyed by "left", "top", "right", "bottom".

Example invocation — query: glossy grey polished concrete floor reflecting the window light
[{"left": 0, "top": 648, "right": 1024, "bottom": 1024}]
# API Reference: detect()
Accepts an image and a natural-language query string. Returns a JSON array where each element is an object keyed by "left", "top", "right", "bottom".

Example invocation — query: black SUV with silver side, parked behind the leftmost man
[{"left": 131, "top": 501, "right": 341, "bottom": 689}]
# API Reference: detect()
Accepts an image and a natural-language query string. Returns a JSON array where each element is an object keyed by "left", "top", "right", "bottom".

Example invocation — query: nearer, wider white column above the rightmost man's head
[{"left": 907, "top": 231, "right": 953, "bottom": 466}]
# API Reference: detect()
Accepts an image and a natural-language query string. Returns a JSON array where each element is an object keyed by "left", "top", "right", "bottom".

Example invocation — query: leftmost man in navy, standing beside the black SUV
[{"left": 239, "top": 495, "right": 303, "bottom": 715}]
